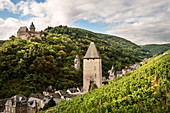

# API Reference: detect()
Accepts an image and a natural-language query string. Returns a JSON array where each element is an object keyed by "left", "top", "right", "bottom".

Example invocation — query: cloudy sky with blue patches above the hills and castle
[{"left": 0, "top": 0, "right": 170, "bottom": 45}]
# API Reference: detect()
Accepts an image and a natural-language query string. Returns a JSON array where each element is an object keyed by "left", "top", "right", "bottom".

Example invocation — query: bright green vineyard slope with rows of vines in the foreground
[{"left": 42, "top": 50, "right": 170, "bottom": 113}]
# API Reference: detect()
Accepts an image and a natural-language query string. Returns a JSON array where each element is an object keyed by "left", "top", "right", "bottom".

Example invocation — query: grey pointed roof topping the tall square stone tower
[{"left": 83, "top": 42, "right": 101, "bottom": 59}]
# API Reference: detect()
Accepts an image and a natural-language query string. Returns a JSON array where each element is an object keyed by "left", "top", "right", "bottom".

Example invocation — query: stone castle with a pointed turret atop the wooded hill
[{"left": 17, "top": 22, "right": 43, "bottom": 40}]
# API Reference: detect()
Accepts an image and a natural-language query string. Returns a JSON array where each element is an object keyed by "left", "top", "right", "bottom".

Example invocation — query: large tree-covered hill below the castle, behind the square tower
[{"left": 0, "top": 26, "right": 151, "bottom": 98}]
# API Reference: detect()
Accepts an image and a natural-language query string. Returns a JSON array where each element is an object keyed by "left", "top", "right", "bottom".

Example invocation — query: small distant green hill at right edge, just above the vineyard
[{"left": 141, "top": 44, "right": 170, "bottom": 55}]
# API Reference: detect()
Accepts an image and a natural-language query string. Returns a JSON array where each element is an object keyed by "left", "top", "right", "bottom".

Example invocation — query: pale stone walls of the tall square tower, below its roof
[{"left": 83, "top": 59, "right": 102, "bottom": 92}]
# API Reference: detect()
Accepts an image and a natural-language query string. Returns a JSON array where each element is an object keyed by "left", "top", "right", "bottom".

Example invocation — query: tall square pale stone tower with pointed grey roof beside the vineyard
[{"left": 83, "top": 42, "right": 102, "bottom": 92}]
